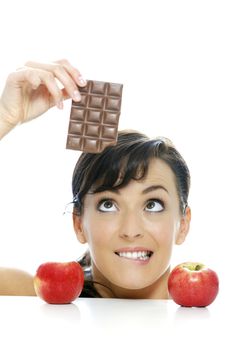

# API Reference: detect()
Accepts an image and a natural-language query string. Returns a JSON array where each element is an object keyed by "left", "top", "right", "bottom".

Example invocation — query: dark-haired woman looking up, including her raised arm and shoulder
[{"left": 0, "top": 60, "right": 191, "bottom": 299}]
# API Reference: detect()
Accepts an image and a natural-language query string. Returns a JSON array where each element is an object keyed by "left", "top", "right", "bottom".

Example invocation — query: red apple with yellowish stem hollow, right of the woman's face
[{"left": 168, "top": 262, "right": 219, "bottom": 307}]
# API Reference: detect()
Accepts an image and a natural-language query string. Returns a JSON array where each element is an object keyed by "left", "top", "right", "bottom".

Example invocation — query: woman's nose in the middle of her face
[{"left": 119, "top": 212, "right": 144, "bottom": 240}]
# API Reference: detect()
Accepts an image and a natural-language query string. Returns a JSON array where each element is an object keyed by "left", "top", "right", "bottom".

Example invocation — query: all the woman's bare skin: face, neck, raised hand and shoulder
[{"left": 0, "top": 60, "right": 191, "bottom": 299}]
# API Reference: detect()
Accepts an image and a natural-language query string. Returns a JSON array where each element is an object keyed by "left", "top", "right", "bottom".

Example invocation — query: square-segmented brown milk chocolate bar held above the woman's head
[{"left": 66, "top": 80, "right": 123, "bottom": 153}]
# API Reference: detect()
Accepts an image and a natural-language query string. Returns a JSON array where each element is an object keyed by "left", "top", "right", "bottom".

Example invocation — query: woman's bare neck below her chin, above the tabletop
[{"left": 92, "top": 265, "right": 170, "bottom": 299}]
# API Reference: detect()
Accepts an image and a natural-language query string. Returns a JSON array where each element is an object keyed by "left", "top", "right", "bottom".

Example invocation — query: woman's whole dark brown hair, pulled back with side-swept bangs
[{"left": 72, "top": 130, "right": 190, "bottom": 296}]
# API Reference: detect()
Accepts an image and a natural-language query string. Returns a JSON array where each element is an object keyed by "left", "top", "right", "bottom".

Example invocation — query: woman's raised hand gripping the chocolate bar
[{"left": 0, "top": 59, "right": 86, "bottom": 127}]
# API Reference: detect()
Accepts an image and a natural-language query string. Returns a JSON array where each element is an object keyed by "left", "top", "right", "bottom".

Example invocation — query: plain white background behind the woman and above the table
[{"left": 0, "top": 0, "right": 233, "bottom": 302}]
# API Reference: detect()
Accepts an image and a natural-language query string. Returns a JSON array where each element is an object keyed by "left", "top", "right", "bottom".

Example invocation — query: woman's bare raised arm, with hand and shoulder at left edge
[{"left": 0, "top": 59, "right": 86, "bottom": 295}]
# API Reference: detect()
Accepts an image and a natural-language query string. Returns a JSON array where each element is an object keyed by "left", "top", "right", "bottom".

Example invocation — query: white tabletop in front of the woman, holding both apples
[{"left": 0, "top": 296, "right": 229, "bottom": 350}]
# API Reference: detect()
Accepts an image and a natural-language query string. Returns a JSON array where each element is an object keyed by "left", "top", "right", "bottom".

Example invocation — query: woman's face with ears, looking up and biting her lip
[{"left": 74, "top": 159, "right": 189, "bottom": 298}]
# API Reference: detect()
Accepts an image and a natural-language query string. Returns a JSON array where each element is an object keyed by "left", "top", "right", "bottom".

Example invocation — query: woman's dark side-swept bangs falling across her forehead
[{"left": 72, "top": 131, "right": 174, "bottom": 213}]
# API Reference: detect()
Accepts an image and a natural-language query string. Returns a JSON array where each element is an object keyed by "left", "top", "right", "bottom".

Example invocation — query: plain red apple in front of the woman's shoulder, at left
[{"left": 34, "top": 261, "right": 84, "bottom": 304}]
